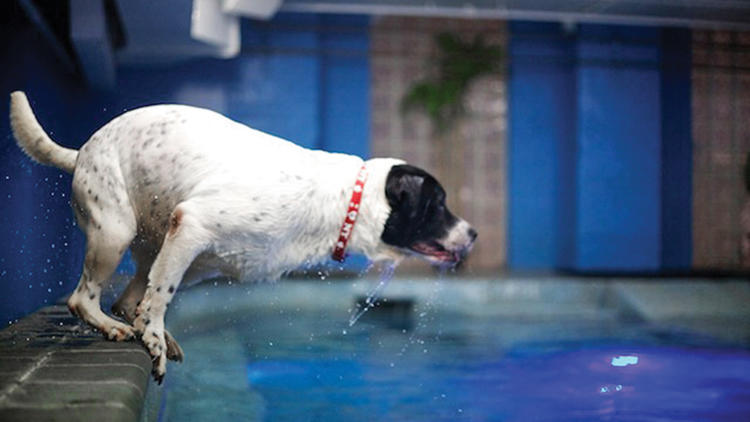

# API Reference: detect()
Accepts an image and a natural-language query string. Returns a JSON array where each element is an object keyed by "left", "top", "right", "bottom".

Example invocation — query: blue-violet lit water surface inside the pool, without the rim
[{"left": 161, "top": 298, "right": 750, "bottom": 421}]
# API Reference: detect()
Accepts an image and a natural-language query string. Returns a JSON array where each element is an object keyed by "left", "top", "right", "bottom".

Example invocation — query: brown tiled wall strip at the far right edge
[{"left": 692, "top": 31, "right": 750, "bottom": 269}]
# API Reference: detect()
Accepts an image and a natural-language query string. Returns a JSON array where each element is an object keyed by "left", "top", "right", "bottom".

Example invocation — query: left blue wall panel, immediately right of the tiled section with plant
[{"left": 508, "top": 22, "right": 576, "bottom": 269}]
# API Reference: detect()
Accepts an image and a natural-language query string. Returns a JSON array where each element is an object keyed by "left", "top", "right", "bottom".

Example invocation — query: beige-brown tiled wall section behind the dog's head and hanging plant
[{"left": 370, "top": 17, "right": 507, "bottom": 274}]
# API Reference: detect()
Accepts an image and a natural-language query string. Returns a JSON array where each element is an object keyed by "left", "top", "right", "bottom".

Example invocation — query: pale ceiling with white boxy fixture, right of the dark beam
[{"left": 117, "top": 0, "right": 750, "bottom": 63}]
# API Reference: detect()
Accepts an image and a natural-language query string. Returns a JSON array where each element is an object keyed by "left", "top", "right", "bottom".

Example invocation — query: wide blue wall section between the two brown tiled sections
[{"left": 509, "top": 22, "right": 692, "bottom": 272}]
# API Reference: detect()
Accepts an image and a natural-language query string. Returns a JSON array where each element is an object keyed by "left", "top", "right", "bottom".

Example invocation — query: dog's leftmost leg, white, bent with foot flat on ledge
[{"left": 68, "top": 221, "right": 135, "bottom": 341}]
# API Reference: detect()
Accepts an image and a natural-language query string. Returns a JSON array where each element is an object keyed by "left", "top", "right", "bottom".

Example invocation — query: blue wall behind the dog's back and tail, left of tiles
[{"left": 0, "top": 14, "right": 370, "bottom": 321}]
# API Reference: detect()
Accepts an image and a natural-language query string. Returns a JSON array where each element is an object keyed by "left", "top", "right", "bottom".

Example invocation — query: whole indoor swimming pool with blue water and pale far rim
[{"left": 151, "top": 280, "right": 750, "bottom": 421}]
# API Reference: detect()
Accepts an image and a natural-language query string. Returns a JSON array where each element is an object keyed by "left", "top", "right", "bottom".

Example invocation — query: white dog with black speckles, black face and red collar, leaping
[{"left": 10, "top": 91, "right": 477, "bottom": 383}]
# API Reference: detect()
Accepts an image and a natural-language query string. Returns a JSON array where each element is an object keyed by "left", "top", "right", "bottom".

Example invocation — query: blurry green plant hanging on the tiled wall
[{"left": 401, "top": 33, "right": 502, "bottom": 130}]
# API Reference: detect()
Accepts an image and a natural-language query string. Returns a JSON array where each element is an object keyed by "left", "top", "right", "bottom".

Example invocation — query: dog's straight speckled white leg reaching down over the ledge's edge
[{"left": 133, "top": 203, "right": 207, "bottom": 384}]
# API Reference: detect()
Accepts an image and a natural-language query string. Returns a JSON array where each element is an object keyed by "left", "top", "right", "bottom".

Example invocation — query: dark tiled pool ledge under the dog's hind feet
[{"left": 0, "top": 305, "right": 151, "bottom": 422}]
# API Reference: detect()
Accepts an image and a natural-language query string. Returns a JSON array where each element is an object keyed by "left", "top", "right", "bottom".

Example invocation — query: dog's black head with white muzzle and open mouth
[{"left": 380, "top": 165, "right": 477, "bottom": 266}]
